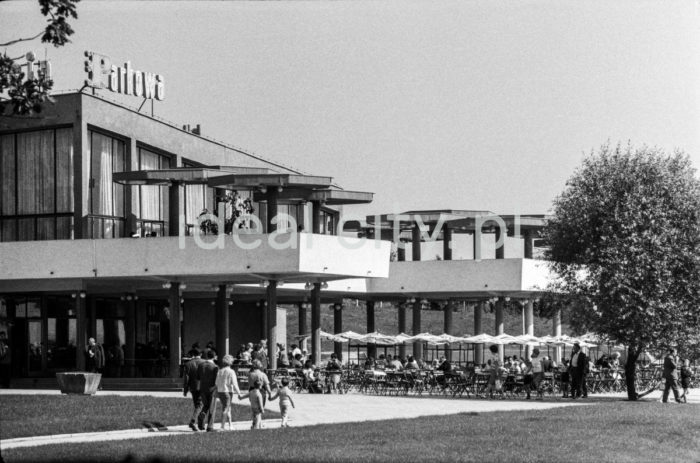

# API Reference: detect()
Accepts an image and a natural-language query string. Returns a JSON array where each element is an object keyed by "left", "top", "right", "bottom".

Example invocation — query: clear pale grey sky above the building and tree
[{"left": 0, "top": 0, "right": 700, "bottom": 220}]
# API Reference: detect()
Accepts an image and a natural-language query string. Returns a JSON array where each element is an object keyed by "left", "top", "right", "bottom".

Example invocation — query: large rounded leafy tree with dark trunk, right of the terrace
[{"left": 544, "top": 145, "right": 700, "bottom": 400}]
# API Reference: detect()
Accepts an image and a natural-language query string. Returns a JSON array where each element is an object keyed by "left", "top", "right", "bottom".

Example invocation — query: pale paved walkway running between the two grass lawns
[{"left": 0, "top": 389, "right": 700, "bottom": 449}]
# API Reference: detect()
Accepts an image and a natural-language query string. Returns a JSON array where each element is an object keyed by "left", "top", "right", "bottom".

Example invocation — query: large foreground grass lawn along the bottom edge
[{"left": 3, "top": 399, "right": 700, "bottom": 463}]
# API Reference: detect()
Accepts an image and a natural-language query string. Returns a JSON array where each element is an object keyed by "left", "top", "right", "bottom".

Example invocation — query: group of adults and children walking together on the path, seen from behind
[{"left": 183, "top": 347, "right": 295, "bottom": 432}]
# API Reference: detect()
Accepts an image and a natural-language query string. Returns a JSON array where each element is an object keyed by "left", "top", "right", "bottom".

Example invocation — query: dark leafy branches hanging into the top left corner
[{"left": 0, "top": 0, "right": 80, "bottom": 116}]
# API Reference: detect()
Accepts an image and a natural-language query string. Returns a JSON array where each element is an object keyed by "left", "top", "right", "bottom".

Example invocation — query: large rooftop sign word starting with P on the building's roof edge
[{"left": 85, "top": 51, "right": 165, "bottom": 100}]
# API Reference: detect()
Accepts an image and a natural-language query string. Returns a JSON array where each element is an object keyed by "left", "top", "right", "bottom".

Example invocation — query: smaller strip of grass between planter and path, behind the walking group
[{"left": 0, "top": 395, "right": 279, "bottom": 439}]
